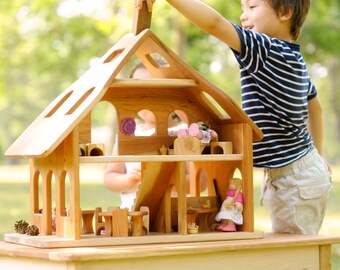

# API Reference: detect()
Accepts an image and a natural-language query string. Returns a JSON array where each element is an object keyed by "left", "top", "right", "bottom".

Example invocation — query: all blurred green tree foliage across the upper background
[{"left": 0, "top": 0, "right": 340, "bottom": 162}]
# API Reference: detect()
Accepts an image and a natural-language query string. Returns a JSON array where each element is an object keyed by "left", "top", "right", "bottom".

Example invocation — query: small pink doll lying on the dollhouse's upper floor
[{"left": 177, "top": 122, "right": 218, "bottom": 143}]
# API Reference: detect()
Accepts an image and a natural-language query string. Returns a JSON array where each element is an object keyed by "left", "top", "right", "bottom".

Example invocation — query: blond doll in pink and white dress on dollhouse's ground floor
[{"left": 216, "top": 178, "right": 243, "bottom": 232}]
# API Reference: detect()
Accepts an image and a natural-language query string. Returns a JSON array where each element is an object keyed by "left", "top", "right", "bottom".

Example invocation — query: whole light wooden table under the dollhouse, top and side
[{"left": 0, "top": 234, "right": 340, "bottom": 270}]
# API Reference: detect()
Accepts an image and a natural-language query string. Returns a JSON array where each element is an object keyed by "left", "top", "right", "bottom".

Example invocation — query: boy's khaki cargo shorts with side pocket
[{"left": 264, "top": 149, "right": 332, "bottom": 234}]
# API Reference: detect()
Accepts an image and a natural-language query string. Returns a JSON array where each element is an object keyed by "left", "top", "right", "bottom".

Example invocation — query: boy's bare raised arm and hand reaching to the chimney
[{"left": 135, "top": 0, "right": 241, "bottom": 51}]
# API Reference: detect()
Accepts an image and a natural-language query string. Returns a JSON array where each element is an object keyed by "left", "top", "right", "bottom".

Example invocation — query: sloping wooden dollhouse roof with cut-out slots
[{"left": 5, "top": 29, "right": 262, "bottom": 158}]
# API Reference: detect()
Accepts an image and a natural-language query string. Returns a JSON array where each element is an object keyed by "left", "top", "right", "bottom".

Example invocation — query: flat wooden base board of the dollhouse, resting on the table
[{"left": 4, "top": 231, "right": 264, "bottom": 248}]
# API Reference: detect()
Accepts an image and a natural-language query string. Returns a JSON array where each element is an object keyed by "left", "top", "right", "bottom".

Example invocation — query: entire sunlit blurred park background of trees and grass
[{"left": 0, "top": 0, "right": 340, "bottom": 269}]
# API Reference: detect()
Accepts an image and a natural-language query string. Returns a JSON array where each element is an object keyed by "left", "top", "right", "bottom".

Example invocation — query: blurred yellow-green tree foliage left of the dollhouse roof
[{"left": 0, "top": 0, "right": 131, "bottom": 162}]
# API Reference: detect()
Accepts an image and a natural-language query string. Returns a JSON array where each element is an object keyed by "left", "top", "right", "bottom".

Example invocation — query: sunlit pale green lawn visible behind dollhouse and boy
[{"left": 0, "top": 162, "right": 340, "bottom": 270}]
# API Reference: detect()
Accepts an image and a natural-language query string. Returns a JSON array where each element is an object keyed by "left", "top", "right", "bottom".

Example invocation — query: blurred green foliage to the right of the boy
[{"left": 300, "top": 0, "right": 340, "bottom": 163}]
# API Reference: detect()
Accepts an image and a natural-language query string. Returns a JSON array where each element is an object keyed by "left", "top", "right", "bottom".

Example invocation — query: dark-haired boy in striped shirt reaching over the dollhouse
[{"left": 135, "top": 0, "right": 331, "bottom": 234}]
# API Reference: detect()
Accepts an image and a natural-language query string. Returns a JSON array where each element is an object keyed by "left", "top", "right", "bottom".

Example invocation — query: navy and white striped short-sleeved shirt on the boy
[{"left": 234, "top": 25, "right": 317, "bottom": 168}]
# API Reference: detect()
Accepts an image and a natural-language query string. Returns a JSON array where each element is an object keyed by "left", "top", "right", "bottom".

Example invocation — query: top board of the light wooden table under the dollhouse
[{"left": 0, "top": 234, "right": 340, "bottom": 261}]
